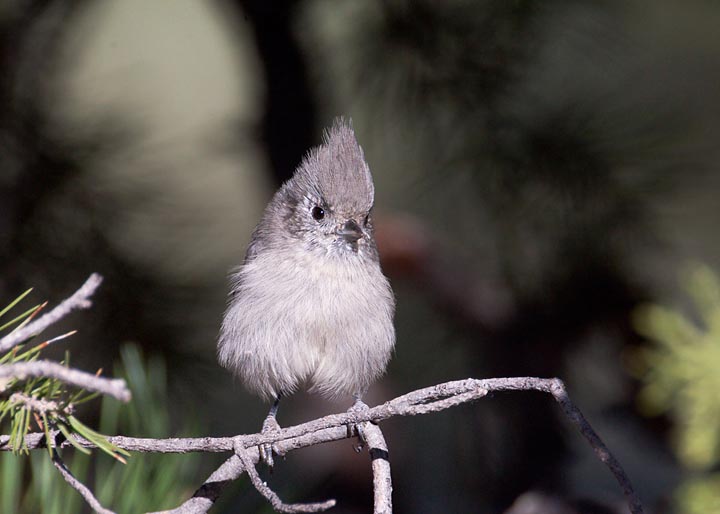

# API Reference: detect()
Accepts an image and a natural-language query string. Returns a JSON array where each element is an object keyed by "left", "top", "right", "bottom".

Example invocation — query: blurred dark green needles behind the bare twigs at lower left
[{"left": 0, "top": 344, "right": 200, "bottom": 514}]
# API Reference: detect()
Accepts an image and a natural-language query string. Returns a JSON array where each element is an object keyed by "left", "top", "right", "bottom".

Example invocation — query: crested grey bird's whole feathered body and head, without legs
[{"left": 218, "top": 120, "right": 395, "bottom": 400}]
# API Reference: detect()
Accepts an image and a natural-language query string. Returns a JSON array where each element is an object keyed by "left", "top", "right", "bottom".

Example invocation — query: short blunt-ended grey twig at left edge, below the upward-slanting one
[{"left": 0, "top": 361, "right": 130, "bottom": 402}]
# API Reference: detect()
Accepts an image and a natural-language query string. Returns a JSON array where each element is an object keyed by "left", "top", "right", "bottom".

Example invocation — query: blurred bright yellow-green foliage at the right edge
[{"left": 633, "top": 265, "right": 720, "bottom": 514}]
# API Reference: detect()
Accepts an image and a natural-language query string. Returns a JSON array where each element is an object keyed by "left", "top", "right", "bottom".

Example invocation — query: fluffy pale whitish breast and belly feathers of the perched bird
[{"left": 219, "top": 248, "right": 395, "bottom": 399}]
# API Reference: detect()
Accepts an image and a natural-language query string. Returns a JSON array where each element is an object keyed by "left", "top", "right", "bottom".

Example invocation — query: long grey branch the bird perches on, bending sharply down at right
[{"left": 0, "top": 377, "right": 643, "bottom": 514}]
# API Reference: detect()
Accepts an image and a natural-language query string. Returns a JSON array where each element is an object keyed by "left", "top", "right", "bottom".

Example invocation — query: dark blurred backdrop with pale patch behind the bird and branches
[{"left": 0, "top": 0, "right": 720, "bottom": 514}]
